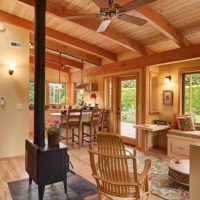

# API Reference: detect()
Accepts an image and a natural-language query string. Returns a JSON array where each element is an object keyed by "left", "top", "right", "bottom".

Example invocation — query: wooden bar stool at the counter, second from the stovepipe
[{"left": 82, "top": 109, "right": 105, "bottom": 144}]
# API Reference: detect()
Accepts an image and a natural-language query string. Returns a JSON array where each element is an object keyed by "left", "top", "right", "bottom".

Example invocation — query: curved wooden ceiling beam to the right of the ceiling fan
[{"left": 119, "top": 0, "right": 191, "bottom": 47}]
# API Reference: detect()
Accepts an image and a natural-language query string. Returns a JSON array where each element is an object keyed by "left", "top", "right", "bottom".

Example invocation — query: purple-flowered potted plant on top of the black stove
[{"left": 47, "top": 120, "right": 63, "bottom": 146}]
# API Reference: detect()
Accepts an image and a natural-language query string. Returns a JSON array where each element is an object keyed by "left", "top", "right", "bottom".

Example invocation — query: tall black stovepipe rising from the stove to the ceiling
[{"left": 34, "top": 0, "right": 46, "bottom": 147}]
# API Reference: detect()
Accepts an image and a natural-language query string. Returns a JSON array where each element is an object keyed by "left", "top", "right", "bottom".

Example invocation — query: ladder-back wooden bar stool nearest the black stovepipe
[{"left": 66, "top": 109, "right": 82, "bottom": 147}]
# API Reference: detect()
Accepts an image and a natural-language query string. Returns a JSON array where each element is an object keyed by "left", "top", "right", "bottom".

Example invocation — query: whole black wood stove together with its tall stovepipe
[{"left": 25, "top": 0, "right": 69, "bottom": 200}]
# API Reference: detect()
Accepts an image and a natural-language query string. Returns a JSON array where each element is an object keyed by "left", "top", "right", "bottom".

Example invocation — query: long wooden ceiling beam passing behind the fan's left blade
[{"left": 18, "top": 0, "right": 154, "bottom": 55}]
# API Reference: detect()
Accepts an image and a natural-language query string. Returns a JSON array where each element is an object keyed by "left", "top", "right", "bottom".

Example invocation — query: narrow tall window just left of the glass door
[{"left": 104, "top": 78, "right": 113, "bottom": 110}]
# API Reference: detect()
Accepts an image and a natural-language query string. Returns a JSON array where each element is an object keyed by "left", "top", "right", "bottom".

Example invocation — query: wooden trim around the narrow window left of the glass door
[{"left": 103, "top": 76, "right": 113, "bottom": 111}]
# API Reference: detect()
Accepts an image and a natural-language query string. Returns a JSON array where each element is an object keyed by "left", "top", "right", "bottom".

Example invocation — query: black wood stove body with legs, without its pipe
[{"left": 25, "top": 140, "right": 69, "bottom": 200}]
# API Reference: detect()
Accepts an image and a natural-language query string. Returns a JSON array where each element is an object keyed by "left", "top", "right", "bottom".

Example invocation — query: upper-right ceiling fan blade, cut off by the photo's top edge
[{"left": 121, "top": 0, "right": 156, "bottom": 12}]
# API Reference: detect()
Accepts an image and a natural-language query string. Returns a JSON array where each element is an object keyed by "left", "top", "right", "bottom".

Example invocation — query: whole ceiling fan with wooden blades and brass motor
[{"left": 64, "top": 0, "right": 156, "bottom": 32}]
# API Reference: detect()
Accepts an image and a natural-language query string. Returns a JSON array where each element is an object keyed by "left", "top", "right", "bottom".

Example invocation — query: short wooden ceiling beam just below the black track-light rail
[{"left": 29, "top": 49, "right": 83, "bottom": 69}]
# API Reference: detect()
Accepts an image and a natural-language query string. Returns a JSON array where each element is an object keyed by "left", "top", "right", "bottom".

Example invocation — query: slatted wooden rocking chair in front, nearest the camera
[{"left": 89, "top": 145, "right": 151, "bottom": 200}]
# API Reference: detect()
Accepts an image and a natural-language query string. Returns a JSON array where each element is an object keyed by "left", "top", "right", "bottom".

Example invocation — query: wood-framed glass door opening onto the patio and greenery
[{"left": 117, "top": 77, "right": 137, "bottom": 145}]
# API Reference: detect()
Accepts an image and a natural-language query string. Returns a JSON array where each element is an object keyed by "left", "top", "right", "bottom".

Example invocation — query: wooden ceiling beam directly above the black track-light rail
[{"left": 30, "top": 33, "right": 101, "bottom": 65}]
